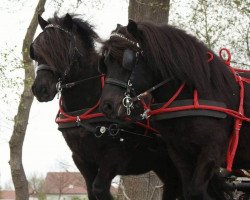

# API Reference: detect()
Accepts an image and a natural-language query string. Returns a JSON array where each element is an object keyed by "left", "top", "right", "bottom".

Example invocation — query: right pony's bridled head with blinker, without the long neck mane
[{"left": 99, "top": 20, "right": 154, "bottom": 118}]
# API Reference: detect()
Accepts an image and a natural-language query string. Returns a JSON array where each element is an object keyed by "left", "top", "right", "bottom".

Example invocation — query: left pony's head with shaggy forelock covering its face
[{"left": 30, "top": 14, "right": 98, "bottom": 102}]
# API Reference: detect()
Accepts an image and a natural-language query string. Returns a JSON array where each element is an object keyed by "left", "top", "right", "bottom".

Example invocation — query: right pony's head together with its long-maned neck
[{"left": 100, "top": 20, "right": 235, "bottom": 118}]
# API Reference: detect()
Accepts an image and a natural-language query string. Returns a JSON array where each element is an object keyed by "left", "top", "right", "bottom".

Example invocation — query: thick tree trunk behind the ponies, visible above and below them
[{"left": 117, "top": 0, "right": 171, "bottom": 200}]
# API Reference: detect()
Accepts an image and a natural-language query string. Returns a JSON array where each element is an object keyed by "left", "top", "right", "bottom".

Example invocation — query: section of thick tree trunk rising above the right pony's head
[{"left": 128, "top": 0, "right": 170, "bottom": 24}]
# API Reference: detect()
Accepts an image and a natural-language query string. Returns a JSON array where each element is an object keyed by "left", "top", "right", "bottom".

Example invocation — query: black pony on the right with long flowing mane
[{"left": 99, "top": 20, "right": 250, "bottom": 200}]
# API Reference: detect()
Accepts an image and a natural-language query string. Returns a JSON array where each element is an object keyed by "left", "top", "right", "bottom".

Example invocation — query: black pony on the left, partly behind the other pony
[{"left": 30, "top": 14, "right": 180, "bottom": 200}]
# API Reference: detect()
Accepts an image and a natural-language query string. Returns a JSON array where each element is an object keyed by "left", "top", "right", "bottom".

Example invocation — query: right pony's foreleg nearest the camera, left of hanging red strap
[{"left": 188, "top": 144, "right": 223, "bottom": 200}]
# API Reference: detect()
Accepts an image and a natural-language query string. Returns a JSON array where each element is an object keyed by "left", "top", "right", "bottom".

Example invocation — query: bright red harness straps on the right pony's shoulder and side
[{"left": 148, "top": 48, "right": 250, "bottom": 171}]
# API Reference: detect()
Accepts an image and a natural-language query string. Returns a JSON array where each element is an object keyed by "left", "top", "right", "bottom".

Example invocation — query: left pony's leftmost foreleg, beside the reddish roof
[{"left": 72, "top": 154, "right": 98, "bottom": 200}]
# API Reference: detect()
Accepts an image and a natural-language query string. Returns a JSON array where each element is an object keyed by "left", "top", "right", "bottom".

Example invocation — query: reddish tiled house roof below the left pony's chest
[{"left": 44, "top": 172, "right": 87, "bottom": 194}]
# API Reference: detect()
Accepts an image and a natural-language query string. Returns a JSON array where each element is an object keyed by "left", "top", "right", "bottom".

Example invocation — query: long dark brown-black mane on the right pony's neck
[{"left": 133, "top": 22, "right": 236, "bottom": 94}]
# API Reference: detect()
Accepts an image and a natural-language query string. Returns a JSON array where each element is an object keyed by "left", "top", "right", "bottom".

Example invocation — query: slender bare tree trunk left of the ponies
[{"left": 9, "top": 0, "right": 46, "bottom": 200}]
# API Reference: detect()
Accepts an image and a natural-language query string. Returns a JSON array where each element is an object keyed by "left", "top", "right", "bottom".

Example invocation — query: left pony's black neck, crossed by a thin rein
[{"left": 62, "top": 56, "right": 102, "bottom": 112}]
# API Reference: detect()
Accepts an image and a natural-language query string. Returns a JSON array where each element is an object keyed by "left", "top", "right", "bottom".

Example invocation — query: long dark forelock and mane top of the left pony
[{"left": 33, "top": 14, "right": 99, "bottom": 73}]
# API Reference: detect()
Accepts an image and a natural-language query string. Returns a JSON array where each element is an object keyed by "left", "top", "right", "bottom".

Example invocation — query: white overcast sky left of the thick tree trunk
[{"left": 0, "top": 0, "right": 128, "bottom": 187}]
